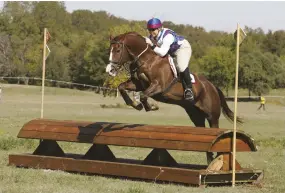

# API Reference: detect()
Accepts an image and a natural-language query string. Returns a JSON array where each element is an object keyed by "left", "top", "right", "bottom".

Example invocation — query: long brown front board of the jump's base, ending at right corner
[{"left": 9, "top": 154, "right": 199, "bottom": 185}]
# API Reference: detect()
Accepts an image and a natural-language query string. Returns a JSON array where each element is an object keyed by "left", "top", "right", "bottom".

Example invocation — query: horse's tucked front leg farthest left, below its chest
[{"left": 118, "top": 80, "right": 143, "bottom": 111}]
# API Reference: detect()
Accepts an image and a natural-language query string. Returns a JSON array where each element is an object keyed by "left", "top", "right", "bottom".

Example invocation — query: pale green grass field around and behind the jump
[{"left": 0, "top": 85, "right": 285, "bottom": 193}]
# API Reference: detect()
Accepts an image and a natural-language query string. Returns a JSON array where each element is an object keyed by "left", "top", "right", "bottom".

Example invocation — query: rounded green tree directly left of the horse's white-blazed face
[{"left": 69, "top": 32, "right": 109, "bottom": 85}]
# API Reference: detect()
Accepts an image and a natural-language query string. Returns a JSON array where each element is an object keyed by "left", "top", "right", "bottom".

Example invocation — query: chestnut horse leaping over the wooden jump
[{"left": 106, "top": 32, "right": 243, "bottom": 161}]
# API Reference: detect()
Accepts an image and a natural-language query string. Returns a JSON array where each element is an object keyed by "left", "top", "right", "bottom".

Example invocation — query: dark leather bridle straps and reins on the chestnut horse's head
[{"left": 109, "top": 35, "right": 149, "bottom": 74}]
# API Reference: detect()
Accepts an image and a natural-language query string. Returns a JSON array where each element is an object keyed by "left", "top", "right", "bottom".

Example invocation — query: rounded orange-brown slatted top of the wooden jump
[{"left": 18, "top": 119, "right": 256, "bottom": 152}]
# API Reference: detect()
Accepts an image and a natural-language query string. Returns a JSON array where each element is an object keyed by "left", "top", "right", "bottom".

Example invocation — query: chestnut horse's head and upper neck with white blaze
[{"left": 106, "top": 32, "right": 148, "bottom": 76}]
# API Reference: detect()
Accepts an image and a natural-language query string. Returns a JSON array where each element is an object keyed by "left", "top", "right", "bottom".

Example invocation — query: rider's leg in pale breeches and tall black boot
[{"left": 176, "top": 40, "right": 194, "bottom": 101}]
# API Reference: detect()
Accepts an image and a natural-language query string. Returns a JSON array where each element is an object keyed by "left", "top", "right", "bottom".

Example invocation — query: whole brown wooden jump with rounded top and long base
[{"left": 9, "top": 119, "right": 263, "bottom": 186}]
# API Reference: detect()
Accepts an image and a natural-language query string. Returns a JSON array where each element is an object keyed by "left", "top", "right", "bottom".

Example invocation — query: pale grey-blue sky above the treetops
[{"left": 65, "top": 1, "right": 285, "bottom": 32}]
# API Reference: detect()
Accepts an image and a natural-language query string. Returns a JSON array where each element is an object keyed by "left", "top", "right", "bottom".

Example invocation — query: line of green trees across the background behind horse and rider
[{"left": 0, "top": 1, "right": 285, "bottom": 95}]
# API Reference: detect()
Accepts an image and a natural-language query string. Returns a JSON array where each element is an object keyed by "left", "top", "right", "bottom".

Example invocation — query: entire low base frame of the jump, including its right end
[{"left": 9, "top": 154, "right": 263, "bottom": 185}]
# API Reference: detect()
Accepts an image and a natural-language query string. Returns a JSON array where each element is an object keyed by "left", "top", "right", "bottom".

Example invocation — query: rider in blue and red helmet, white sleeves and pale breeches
[{"left": 145, "top": 18, "right": 194, "bottom": 101}]
